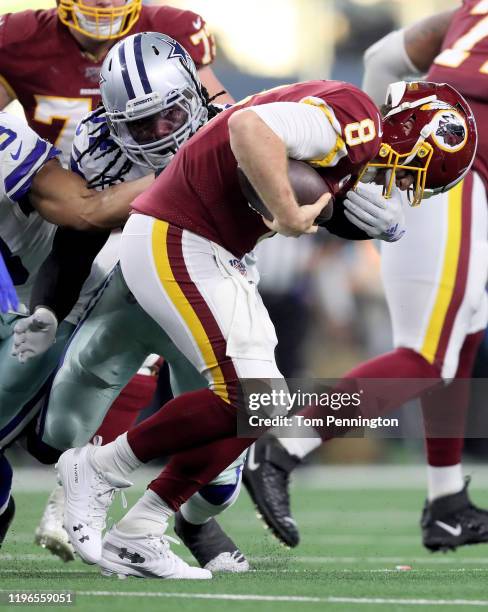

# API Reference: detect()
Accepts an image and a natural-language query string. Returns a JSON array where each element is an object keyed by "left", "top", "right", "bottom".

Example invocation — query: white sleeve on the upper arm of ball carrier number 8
[{"left": 246, "top": 102, "right": 347, "bottom": 166}]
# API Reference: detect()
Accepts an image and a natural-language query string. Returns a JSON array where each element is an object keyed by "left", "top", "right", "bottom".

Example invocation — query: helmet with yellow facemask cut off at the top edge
[{"left": 57, "top": 0, "right": 142, "bottom": 40}]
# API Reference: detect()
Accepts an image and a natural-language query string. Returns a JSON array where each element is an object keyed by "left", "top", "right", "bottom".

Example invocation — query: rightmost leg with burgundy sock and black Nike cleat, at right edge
[{"left": 422, "top": 174, "right": 488, "bottom": 550}]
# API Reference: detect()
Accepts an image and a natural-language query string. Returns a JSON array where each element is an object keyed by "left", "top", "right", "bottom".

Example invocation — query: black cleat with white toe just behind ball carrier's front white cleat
[{"left": 175, "top": 511, "right": 249, "bottom": 573}]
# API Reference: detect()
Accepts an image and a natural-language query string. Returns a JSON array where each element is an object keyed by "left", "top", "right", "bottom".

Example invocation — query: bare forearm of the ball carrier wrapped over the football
[{"left": 229, "top": 111, "right": 300, "bottom": 229}]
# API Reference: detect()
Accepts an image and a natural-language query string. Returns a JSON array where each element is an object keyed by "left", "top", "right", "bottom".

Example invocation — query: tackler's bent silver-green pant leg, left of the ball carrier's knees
[{"left": 41, "top": 268, "right": 167, "bottom": 451}]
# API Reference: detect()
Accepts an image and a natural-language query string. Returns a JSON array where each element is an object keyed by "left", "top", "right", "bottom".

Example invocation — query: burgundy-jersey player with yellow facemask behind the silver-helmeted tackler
[{"left": 0, "top": 0, "right": 231, "bottom": 165}]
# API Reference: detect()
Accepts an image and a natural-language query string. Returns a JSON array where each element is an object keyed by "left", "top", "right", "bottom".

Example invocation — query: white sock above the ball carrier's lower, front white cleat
[{"left": 117, "top": 489, "right": 174, "bottom": 535}]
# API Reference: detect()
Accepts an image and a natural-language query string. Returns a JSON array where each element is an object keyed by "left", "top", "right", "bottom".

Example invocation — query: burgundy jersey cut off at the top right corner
[{"left": 427, "top": 0, "right": 488, "bottom": 186}]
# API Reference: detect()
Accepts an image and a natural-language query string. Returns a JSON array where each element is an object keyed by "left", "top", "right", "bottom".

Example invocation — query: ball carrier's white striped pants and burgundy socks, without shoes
[{"left": 66, "top": 215, "right": 280, "bottom": 572}]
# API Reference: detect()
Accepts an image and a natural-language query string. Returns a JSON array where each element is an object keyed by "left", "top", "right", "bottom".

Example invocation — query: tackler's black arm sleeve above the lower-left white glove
[{"left": 30, "top": 227, "right": 110, "bottom": 321}]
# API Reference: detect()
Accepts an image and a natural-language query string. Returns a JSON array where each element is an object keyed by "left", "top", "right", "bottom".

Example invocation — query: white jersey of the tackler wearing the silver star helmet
[{"left": 66, "top": 110, "right": 152, "bottom": 325}]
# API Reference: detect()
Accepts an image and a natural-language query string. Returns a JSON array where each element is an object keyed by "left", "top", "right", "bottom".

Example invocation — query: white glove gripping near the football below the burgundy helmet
[{"left": 344, "top": 183, "right": 406, "bottom": 242}]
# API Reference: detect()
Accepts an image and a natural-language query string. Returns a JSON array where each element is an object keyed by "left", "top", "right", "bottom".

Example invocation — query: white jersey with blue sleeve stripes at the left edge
[{"left": 0, "top": 112, "right": 60, "bottom": 304}]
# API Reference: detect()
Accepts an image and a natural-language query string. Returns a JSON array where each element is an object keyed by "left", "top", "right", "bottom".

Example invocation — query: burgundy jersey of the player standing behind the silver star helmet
[{"left": 0, "top": 6, "right": 215, "bottom": 165}]
